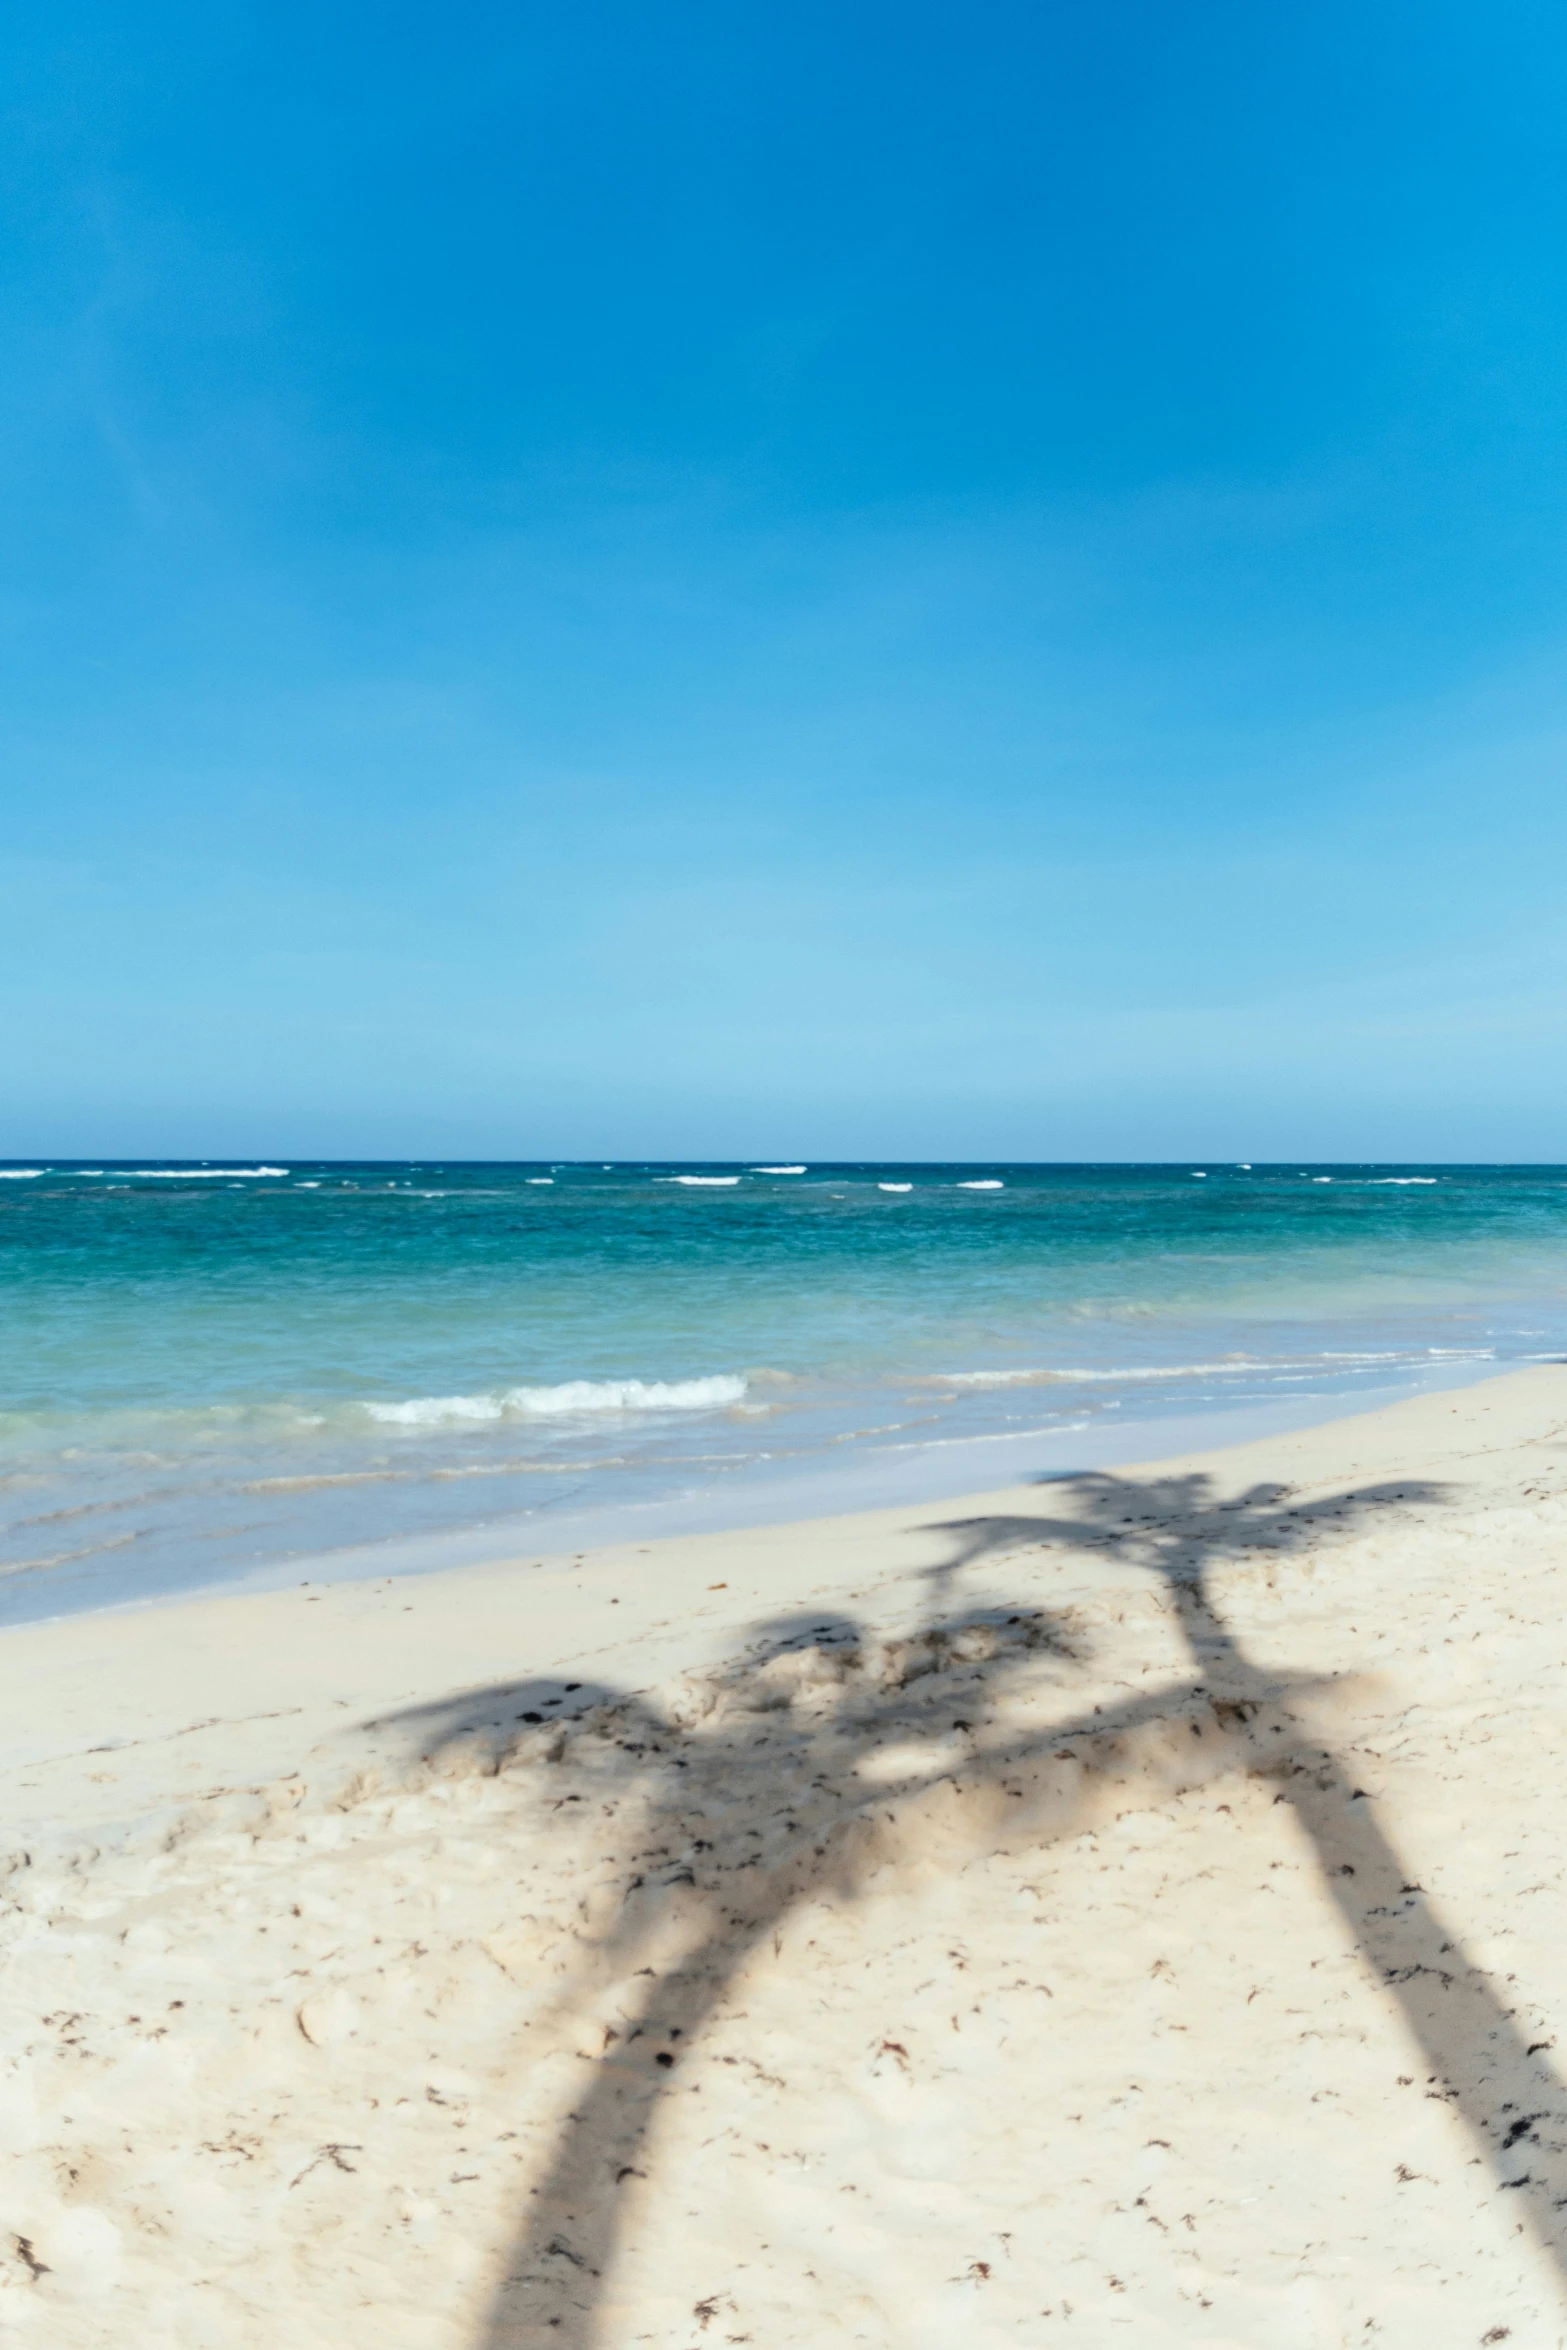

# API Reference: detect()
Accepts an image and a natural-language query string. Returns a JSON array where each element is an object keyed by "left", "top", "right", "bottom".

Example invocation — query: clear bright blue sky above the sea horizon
[{"left": 0, "top": 0, "right": 1567, "bottom": 1159}]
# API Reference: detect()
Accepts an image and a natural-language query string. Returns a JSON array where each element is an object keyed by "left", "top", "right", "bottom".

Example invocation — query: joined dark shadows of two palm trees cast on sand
[{"left": 413, "top": 1476, "right": 1567, "bottom": 2350}]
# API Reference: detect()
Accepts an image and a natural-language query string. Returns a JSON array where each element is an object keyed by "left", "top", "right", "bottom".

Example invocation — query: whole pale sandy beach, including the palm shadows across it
[{"left": 0, "top": 1365, "right": 1567, "bottom": 2350}]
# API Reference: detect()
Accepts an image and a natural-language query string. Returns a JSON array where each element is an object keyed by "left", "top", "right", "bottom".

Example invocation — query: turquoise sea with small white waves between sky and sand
[{"left": 0, "top": 1161, "right": 1567, "bottom": 1614}]
